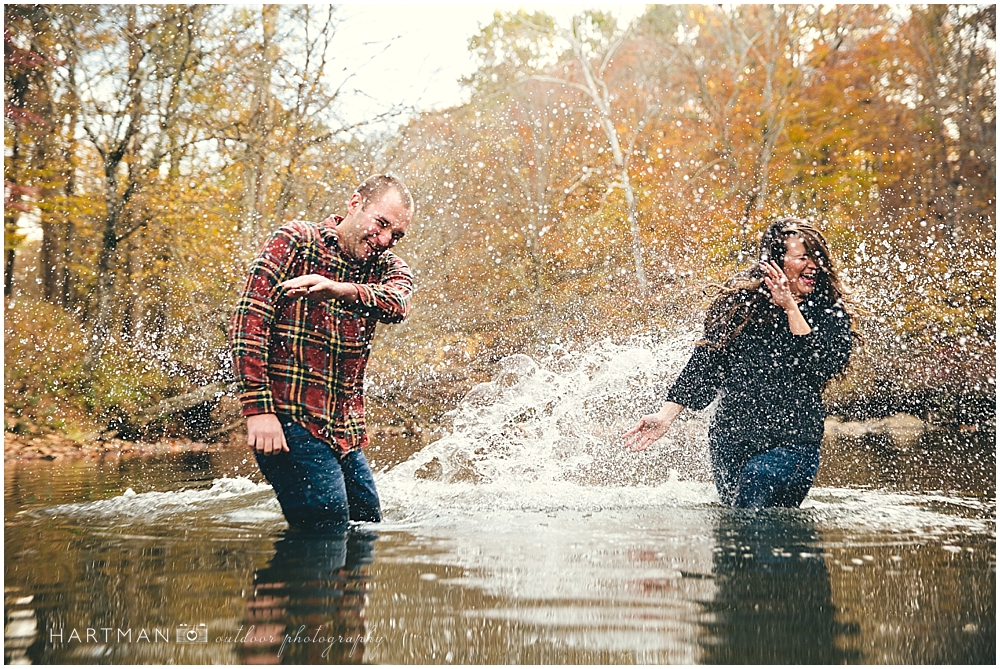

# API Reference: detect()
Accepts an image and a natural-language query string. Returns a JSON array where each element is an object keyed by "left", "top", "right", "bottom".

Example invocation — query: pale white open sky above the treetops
[{"left": 322, "top": 2, "right": 645, "bottom": 130}]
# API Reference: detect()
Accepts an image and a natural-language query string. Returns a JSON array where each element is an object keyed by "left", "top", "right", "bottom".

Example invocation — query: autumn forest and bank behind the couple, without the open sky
[{"left": 4, "top": 4, "right": 996, "bottom": 441}]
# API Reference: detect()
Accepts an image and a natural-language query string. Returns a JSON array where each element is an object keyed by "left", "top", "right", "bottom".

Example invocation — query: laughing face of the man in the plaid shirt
[{"left": 337, "top": 189, "right": 411, "bottom": 263}]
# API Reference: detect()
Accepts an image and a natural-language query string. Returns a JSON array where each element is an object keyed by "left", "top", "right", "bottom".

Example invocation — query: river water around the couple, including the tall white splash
[{"left": 4, "top": 337, "right": 996, "bottom": 665}]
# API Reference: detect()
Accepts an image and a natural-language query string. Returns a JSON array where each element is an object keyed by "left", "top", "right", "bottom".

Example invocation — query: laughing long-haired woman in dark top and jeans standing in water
[{"left": 623, "top": 218, "right": 855, "bottom": 509}]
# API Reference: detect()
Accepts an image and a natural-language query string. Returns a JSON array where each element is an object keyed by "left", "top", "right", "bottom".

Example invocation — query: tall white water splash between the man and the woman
[{"left": 378, "top": 332, "right": 717, "bottom": 509}]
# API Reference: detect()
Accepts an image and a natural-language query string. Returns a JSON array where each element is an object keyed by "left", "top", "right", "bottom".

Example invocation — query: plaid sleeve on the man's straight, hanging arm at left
[{"left": 229, "top": 226, "right": 299, "bottom": 416}]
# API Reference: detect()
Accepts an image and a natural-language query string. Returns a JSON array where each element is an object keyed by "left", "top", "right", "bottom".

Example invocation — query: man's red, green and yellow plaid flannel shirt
[{"left": 229, "top": 216, "right": 413, "bottom": 452}]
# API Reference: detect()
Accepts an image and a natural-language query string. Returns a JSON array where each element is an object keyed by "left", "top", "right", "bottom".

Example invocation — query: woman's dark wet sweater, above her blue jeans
[{"left": 667, "top": 300, "right": 853, "bottom": 447}]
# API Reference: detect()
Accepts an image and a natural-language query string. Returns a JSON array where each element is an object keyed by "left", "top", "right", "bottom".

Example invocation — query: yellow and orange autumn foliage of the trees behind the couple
[{"left": 7, "top": 5, "right": 995, "bottom": 428}]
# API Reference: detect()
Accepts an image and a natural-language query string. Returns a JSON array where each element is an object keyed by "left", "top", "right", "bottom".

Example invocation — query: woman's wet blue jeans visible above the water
[{"left": 709, "top": 439, "right": 819, "bottom": 509}]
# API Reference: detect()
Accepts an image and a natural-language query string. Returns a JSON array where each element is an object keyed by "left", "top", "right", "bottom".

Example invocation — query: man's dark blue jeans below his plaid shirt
[{"left": 254, "top": 418, "right": 382, "bottom": 528}]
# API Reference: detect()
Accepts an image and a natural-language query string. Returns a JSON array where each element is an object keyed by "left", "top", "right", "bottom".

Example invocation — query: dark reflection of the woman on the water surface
[{"left": 699, "top": 510, "right": 859, "bottom": 664}]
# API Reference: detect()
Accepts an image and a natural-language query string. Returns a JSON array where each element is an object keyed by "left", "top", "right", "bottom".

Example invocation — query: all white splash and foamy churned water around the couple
[{"left": 35, "top": 332, "right": 995, "bottom": 532}]
